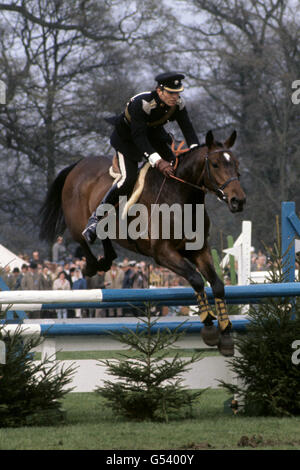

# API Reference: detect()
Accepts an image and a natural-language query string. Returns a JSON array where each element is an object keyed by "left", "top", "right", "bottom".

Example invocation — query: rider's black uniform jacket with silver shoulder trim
[{"left": 112, "top": 91, "right": 199, "bottom": 162}]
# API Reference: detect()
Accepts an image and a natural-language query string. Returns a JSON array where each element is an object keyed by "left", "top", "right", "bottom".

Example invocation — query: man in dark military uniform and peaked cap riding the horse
[{"left": 82, "top": 72, "right": 199, "bottom": 243}]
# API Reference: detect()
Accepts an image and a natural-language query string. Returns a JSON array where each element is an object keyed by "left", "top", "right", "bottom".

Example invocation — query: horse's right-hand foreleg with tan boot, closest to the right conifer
[{"left": 189, "top": 245, "right": 234, "bottom": 356}]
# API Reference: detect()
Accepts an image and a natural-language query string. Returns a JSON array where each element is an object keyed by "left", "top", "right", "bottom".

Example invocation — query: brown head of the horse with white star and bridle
[{"left": 203, "top": 131, "right": 246, "bottom": 212}]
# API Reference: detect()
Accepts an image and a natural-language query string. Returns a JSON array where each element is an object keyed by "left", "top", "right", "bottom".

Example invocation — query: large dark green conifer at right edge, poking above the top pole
[{"left": 222, "top": 243, "right": 300, "bottom": 416}]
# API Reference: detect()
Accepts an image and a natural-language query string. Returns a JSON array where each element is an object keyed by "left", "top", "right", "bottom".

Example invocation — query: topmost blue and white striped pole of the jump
[{"left": 0, "top": 282, "right": 300, "bottom": 311}]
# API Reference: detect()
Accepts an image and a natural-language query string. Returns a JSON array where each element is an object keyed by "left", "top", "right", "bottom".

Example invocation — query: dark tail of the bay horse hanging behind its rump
[{"left": 39, "top": 161, "right": 78, "bottom": 243}]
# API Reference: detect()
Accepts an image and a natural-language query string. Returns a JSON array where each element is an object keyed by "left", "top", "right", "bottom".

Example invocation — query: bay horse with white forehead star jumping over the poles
[{"left": 40, "top": 131, "right": 246, "bottom": 356}]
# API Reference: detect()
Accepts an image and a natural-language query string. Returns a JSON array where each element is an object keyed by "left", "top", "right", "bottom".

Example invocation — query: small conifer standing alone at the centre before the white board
[{"left": 96, "top": 305, "right": 203, "bottom": 422}]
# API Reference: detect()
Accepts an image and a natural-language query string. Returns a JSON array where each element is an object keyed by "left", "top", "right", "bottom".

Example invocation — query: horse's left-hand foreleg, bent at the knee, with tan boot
[{"left": 154, "top": 242, "right": 219, "bottom": 346}]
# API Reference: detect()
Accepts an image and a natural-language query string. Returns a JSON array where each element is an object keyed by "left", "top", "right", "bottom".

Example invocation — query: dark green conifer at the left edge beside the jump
[{"left": 0, "top": 324, "right": 75, "bottom": 427}]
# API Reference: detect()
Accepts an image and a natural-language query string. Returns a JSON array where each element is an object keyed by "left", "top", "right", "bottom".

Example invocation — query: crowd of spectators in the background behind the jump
[{"left": 1, "top": 236, "right": 282, "bottom": 319}]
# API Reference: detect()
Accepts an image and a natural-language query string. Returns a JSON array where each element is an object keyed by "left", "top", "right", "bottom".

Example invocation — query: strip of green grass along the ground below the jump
[{"left": 0, "top": 390, "right": 300, "bottom": 450}]
